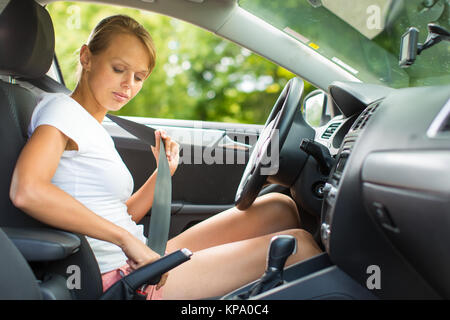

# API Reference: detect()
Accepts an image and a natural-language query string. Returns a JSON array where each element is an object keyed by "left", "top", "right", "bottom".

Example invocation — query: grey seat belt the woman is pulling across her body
[{"left": 106, "top": 114, "right": 172, "bottom": 256}]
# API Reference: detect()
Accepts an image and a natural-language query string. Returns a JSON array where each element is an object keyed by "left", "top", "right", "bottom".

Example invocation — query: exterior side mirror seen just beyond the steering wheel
[{"left": 302, "top": 89, "right": 330, "bottom": 128}]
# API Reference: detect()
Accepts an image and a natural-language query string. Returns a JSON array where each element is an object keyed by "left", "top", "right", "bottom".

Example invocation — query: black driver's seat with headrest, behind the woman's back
[{"left": 0, "top": 0, "right": 102, "bottom": 299}]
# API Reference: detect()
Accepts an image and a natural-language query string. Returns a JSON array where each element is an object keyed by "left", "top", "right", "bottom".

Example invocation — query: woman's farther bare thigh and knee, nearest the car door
[{"left": 167, "top": 193, "right": 300, "bottom": 252}]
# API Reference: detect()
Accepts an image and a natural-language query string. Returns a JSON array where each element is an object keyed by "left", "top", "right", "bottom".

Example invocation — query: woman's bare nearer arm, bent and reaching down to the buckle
[{"left": 10, "top": 125, "right": 159, "bottom": 267}]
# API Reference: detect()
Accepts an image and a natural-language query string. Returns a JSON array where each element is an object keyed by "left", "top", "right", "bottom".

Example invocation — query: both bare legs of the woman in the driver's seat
[{"left": 163, "top": 193, "right": 321, "bottom": 299}]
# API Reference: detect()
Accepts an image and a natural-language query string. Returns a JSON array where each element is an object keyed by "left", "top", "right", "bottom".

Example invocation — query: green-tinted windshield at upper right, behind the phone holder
[{"left": 239, "top": 0, "right": 450, "bottom": 88}]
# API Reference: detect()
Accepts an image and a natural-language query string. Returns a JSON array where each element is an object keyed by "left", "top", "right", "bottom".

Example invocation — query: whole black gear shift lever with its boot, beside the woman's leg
[{"left": 236, "top": 235, "right": 297, "bottom": 299}]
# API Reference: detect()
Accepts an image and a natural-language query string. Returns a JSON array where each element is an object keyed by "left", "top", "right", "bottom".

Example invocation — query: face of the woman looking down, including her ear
[{"left": 81, "top": 34, "right": 150, "bottom": 111}]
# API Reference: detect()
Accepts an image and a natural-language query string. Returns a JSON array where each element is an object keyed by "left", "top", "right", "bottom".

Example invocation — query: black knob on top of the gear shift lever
[{"left": 266, "top": 235, "right": 297, "bottom": 272}]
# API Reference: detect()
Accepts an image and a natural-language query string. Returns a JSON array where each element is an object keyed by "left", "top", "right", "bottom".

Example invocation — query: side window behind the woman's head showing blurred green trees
[{"left": 47, "top": 2, "right": 309, "bottom": 124}]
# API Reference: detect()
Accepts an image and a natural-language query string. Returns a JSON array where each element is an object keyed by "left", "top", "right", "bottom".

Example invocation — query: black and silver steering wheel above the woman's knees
[{"left": 235, "top": 77, "right": 303, "bottom": 210}]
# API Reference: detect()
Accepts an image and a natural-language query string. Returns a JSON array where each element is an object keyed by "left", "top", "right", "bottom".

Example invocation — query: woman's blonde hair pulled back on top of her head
[{"left": 78, "top": 14, "right": 156, "bottom": 79}]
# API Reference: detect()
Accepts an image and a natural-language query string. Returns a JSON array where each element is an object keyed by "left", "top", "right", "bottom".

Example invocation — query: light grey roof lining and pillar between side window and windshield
[{"left": 37, "top": 0, "right": 359, "bottom": 90}]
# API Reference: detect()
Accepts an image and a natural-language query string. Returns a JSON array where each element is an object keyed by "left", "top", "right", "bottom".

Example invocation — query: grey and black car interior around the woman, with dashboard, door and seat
[{"left": 0, "top": 0, "right": 450, "bottom": 300}]
